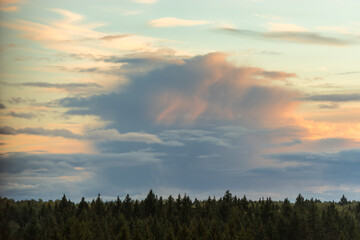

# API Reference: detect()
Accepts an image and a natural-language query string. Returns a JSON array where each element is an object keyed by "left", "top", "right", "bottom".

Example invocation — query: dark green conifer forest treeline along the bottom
[{"left": 0, "top": 191, "right": 360, "bottom": 240}]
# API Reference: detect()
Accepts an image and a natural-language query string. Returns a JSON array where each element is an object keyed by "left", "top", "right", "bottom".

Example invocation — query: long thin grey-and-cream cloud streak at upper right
[{"left": 220, "top": 26, "right": 356, "bottom": 47}]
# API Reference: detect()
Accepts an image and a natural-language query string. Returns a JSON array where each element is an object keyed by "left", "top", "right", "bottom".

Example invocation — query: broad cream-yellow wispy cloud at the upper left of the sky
[{"left": 0, "top": 9, "right": 164, "bottom": 59}]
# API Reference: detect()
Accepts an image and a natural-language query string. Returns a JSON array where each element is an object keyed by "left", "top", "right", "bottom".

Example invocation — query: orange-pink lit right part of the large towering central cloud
[{"left": 152, "top": 53, "right": 299, "bottom": 127}]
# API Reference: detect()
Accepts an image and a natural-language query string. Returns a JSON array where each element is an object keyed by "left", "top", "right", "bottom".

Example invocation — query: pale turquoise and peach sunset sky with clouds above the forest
[{"left": 0, "top": 0, "right": 360, "bottom": 201}]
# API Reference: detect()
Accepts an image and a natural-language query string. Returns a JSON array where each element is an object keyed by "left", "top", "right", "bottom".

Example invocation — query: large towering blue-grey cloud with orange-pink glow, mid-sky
[{"left": 51, "top": 53, "right": 299, "bottom": 128}]
